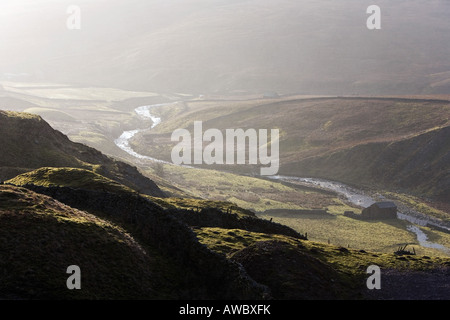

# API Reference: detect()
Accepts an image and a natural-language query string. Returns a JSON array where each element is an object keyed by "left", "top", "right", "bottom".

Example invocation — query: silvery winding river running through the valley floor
[{"left": 114, "top": 102, "right": 450, "bottom": 254}]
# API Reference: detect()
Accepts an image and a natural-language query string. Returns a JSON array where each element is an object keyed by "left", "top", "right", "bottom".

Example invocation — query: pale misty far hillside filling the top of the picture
[{"left": 0, "top": 0, "right": 450, "bottom": 95}]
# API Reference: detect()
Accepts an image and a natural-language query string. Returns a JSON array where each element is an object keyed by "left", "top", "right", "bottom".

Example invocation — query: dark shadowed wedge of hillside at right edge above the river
[{"left": 284, "top": 127, "right": 450, "bottom": 202}]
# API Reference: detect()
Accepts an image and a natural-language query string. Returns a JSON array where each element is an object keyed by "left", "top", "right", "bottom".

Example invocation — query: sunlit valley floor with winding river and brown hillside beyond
[{"left": 4, "top": 81, "right": 450, "bottom": 255}]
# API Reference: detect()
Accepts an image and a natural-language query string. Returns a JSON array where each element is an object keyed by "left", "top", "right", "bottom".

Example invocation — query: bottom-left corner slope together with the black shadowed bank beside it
[{"left": 0, "top": 175, "right": 274, "bottom": 300}]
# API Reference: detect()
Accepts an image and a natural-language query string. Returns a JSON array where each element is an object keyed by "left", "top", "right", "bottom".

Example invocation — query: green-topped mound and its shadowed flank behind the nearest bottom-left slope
[{"left": 7, "top": 168, "right": 274, "bottom": 299}]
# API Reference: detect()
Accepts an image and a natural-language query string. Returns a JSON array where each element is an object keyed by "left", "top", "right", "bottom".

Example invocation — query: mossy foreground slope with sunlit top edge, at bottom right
[{"left": 196, "top": 228, "right": 450, "bottom": 300}]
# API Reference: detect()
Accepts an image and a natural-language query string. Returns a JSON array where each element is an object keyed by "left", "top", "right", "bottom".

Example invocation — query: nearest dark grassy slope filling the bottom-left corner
[{"left": 0, "top": 186, "right": 170, "bottom": 299}]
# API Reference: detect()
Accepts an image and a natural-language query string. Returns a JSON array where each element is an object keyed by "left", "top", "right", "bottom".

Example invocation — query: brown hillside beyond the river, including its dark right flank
[{"left": 131, "top": 97, "right": 450, "bottom": 205}]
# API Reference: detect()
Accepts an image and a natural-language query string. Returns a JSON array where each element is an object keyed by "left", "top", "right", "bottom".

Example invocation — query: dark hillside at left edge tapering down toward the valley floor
[{"left": 0, "top": 110, "right": 165, "bottom": 197}]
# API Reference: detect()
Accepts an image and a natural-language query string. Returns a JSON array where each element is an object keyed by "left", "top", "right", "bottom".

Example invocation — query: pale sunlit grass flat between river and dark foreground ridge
[{"left": 146, "top": 164, "right": 354, "bottom": 214}]
